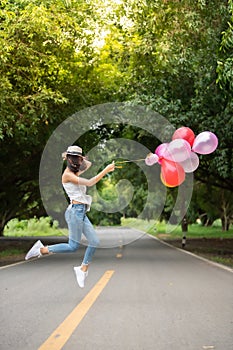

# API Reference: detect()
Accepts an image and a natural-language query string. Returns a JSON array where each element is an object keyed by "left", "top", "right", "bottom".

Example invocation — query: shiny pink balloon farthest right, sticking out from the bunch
[{"left": 192, "top": 131, "right": 218, "bottom": 154}]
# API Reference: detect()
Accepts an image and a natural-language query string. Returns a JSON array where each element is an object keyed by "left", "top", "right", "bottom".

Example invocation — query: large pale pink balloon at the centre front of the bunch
[{"left": 163, "top": 139, "right": 191, "bottom": 163}]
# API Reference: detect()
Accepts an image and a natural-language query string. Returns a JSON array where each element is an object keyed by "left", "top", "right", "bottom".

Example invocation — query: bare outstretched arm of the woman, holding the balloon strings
[{"left": 62, "top": 162, "right": 115, "bottom": 187}]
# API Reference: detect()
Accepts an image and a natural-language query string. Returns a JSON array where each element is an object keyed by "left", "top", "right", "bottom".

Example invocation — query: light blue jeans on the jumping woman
[{"left": 48, "top": 204, "right": 99, "bottom": 265}]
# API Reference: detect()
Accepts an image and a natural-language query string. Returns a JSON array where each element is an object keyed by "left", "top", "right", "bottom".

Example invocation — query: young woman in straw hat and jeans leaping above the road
[{"left": 25, "top": 146, "right": 115, "bottom": 288}]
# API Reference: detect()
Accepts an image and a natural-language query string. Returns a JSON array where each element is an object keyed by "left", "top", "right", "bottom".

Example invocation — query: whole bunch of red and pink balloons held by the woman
[{"left": 145, "top": 127, "right": 218, "bottom": 187}]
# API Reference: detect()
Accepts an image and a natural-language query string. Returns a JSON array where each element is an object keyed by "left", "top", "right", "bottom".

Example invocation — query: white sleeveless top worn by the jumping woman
[{"left": 62, "top": 182, "right": 92, "bottom": 211}]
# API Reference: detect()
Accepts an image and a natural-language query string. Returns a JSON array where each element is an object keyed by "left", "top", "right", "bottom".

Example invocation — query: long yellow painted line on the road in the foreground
[{"left": 38, "top": 270, "right": 114, "bottom": 350}]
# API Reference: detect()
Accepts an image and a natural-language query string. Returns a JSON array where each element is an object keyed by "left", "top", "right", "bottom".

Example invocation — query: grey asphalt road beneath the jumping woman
[{"left": 0, "top": 228, "right": 233, "bottom": 350}]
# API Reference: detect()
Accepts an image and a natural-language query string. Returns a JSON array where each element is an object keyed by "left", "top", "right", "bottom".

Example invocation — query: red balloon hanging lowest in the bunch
[{"left": 161, "top": 159, "right": 185, "bottom": 187}]
